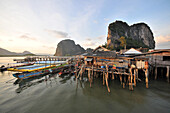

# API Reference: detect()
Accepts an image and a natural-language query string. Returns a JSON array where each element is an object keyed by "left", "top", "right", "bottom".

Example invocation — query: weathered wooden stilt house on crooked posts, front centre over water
[{"left": 75, "top": 48, "right": 149, "bottom": 92}]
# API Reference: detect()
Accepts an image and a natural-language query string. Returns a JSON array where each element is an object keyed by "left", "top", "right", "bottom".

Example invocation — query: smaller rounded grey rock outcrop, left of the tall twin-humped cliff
[{"left": 54, "top": 39, "right": 85, "bottom": 56}]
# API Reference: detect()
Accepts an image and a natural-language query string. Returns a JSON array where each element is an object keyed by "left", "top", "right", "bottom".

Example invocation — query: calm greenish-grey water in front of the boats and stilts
[{"left": 0, "top": 57, "right": 170, "bottom": 113}]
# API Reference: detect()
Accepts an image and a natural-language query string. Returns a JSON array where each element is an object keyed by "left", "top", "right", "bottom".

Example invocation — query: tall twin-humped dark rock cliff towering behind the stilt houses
[{"left": 107, "top": 21, "right": 155, "bottom": 49}]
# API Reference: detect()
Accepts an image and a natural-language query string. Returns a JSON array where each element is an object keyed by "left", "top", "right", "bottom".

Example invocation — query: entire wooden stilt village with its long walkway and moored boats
[{"left": 1, "top": 46, "right": 170, "bottom": 92}]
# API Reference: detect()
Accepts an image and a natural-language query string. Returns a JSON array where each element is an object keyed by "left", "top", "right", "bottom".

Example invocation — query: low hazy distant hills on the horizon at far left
[{"left": 0, "top": 48, "right": 35, "bottom": 57}]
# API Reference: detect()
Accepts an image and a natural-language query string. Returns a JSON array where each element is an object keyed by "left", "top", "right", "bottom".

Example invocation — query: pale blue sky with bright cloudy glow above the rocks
[{"left": 0, "top": 0, "right": 170, "bottom": 54}]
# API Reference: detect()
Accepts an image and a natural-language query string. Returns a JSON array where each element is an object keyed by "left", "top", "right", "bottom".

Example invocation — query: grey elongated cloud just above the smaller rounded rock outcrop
[{"left": 45, "top": 30, "right": 69, "bottom": 38}]
